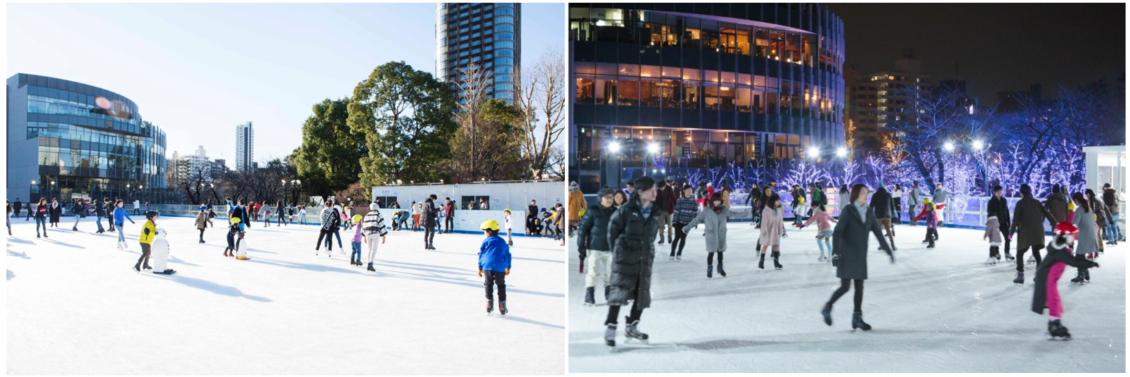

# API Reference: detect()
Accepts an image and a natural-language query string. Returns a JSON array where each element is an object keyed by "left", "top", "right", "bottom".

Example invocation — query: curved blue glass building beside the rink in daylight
[{"left": 7, "top": 73, "right": 167, "bottom": 202}]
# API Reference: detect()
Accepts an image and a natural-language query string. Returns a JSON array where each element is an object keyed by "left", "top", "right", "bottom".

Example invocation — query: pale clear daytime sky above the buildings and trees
[{"left": 6, "top": 3, "right": 565, "bottom": 167}]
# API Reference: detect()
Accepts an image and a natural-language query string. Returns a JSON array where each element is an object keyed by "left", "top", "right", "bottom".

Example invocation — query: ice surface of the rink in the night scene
[{"left": 568, "top": 220, "right": 1127, "bottom": 372}]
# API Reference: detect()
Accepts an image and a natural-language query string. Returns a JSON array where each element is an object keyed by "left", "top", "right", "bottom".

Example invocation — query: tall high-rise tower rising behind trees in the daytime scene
[{"left": 435, "top": 2, "right": 522, "bottom": 104}]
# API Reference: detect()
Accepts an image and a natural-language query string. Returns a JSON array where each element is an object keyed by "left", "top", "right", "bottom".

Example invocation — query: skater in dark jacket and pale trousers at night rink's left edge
[{"left": 576, "top": 189, "right": 616, "bottom": 306}]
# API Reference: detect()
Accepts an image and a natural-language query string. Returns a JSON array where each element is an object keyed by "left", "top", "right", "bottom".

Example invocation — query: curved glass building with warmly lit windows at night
[{"left": 568, "top": 3, "right": 844, "bottom": 193}]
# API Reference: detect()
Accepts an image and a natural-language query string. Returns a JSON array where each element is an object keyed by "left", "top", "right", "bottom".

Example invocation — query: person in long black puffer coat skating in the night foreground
[{"left": 605, "top": 176, "right": 659, "bottom": 347}]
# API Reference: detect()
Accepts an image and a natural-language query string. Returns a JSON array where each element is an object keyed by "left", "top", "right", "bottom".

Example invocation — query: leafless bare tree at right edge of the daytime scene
[{"left": 514, "top": 47, "right": 567, "bottom": 177}]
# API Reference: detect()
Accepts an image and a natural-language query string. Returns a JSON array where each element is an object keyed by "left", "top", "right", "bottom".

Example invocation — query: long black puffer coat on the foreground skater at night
[{"left": 608, "top": 198, "right": 660, "bottom": 309}]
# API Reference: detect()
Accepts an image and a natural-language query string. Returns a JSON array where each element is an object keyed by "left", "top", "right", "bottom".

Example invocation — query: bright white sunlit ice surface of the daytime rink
[{"left": 6, "top": 216, "right": 565, "bottom": 375}]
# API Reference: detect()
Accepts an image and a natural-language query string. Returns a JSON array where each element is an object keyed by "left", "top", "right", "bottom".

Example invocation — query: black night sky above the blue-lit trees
[{"left": 826, "top": 3, "right": 1125, "bottom": 104}]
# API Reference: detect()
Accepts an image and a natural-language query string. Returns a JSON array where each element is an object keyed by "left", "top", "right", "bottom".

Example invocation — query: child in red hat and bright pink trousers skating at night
[{"left": 1032, "top": 222, "right": 1098, "bottom": 340}]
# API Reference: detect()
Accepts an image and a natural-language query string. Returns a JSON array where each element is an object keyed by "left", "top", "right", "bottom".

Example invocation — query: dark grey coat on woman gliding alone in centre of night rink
[{"left": 832, "top": 205, "right": 894, "bottom": 279}]
